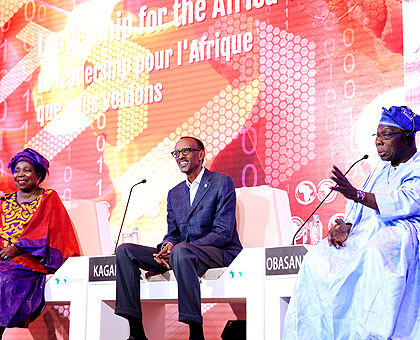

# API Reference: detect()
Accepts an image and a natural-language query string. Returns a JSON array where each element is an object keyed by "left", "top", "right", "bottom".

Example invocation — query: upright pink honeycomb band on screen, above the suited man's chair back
[{"left": 256, "top": 22, "right": 315, "bottom": 187}]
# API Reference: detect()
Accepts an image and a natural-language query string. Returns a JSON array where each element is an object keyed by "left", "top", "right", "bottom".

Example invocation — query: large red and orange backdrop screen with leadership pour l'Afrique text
[{"left": 0, "top": 0, "right": 410, "bottom": 245}]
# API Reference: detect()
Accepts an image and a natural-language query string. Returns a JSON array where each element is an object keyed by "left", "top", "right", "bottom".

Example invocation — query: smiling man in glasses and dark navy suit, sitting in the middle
[{"left": 115, "top": 137, "right": 242, "bottom": 340}]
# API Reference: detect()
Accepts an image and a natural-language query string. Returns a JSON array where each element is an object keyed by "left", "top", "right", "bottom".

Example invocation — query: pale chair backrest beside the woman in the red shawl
[{"left": 63, "top": 200, "right": 112, "bottom": 256}]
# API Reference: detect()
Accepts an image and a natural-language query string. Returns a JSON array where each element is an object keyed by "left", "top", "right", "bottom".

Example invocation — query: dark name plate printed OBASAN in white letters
[{"left": 265, "top": 246, "right": 308, "bottom": 276}]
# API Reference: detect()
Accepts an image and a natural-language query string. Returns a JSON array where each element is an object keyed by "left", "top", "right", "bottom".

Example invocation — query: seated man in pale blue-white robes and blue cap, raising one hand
[{"left": 283, "top": 106, "right": 420, "bottom": 340}]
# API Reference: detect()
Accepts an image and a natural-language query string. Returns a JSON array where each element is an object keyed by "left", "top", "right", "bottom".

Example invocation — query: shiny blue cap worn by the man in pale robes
[{"left": 379, "top": 106, "right": 420, "bottom": 133}]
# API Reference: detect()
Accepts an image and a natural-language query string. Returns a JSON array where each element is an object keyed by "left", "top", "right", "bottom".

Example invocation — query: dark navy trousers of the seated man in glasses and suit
[{"left": 115, "top": 242, "right": 233, "bottom": 324}]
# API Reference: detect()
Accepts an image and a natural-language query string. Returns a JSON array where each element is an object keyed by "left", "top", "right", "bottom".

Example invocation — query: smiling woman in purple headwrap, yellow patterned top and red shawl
[{"left": 0, "top": 148, "right": 80, "bottom": 339}]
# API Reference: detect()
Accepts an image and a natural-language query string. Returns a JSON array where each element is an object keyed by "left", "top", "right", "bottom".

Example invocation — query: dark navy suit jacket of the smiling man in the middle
[{"left": 162, "top": 169, "right": 242, "bottom": 262}]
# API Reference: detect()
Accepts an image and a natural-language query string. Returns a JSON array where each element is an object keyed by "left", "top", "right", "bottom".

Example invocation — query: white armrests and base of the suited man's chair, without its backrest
[{"left": 86, "top": 248, "right": 265, "bottom": 340}]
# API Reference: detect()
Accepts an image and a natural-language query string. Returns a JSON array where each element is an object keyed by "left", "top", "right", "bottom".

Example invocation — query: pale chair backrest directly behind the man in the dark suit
[{"left": 236, "top": 185, "right": 295, "bottom": 248}]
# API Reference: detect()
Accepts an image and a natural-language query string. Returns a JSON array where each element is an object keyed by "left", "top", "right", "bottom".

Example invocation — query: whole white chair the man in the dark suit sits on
[{"left": 86, "top": 186, "right": 294, "bottom": 340}]
